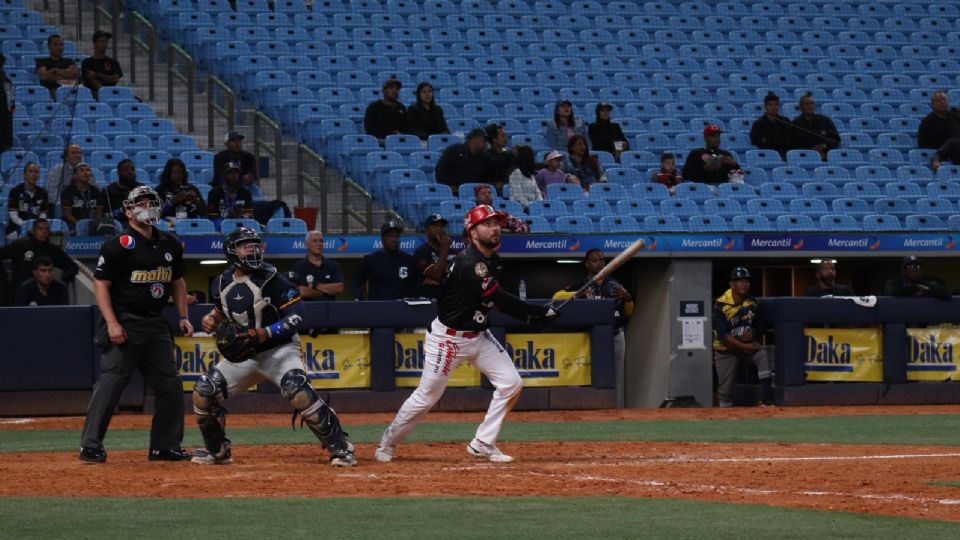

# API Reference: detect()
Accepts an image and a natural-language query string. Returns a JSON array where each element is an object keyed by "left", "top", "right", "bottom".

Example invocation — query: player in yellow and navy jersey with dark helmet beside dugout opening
[{"left": 713, "top": 266, "right": 773, "bottom": 407}]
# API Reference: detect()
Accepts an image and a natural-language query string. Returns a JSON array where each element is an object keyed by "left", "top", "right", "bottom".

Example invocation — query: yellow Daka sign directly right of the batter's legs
[{"left": 506, "top": 332, "right": 591, "bottom": 387}]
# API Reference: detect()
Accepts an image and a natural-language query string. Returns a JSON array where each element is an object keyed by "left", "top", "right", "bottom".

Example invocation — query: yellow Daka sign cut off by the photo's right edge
[{"left": 907, "top": 328, "right": 960, "bottom": 381}]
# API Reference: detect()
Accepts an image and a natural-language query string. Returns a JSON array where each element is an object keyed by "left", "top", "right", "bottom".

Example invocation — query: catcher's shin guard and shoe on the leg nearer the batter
[{"left": 280, "top": 369, "right": 355, "bottom": 466}]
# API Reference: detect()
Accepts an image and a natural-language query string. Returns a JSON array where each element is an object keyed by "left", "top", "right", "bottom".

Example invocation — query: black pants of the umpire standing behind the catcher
[{"left": 81, "top": 314, "right": 183, "bottom": 450}]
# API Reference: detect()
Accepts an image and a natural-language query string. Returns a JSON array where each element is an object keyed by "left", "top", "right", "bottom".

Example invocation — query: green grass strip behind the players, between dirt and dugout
[{"left": 0, "top": 414, "right": 960, "bottom": 452}]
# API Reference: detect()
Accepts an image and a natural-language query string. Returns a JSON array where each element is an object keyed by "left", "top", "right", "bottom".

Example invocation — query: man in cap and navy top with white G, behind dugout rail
[{"left": 353, "top": 220, "right": 420, "bottom": 300}]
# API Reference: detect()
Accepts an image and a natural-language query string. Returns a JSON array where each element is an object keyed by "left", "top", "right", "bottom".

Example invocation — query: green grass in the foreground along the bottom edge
[{"left": 0, "top": 498, "right": 960, "bottom": 540}]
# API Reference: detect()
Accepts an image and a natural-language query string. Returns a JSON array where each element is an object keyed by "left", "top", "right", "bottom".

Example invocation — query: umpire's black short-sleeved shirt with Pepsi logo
[{"left": 94, "top": 228, "right": 184, "bottom": 317}]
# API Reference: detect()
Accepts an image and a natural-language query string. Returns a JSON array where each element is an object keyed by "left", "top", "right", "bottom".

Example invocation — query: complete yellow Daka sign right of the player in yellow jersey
[{"left": 803, "top": 328, "right": 883, "bottom": 382}]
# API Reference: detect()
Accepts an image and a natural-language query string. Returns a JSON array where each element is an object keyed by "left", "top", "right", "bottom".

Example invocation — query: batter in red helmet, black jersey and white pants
[{"left": 374, "top": 205, "right": 557, "bottom": 463}]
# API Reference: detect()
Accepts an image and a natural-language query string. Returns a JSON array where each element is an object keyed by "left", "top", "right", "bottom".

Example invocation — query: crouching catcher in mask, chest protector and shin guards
[{"left": 192, "top": 227, "right": 356, "bottom": 467}]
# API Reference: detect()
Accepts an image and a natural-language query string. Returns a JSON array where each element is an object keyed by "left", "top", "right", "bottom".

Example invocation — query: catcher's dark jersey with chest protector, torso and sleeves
[{"left": 211, "top": 264, "right": 306, "bottom": 351}]
